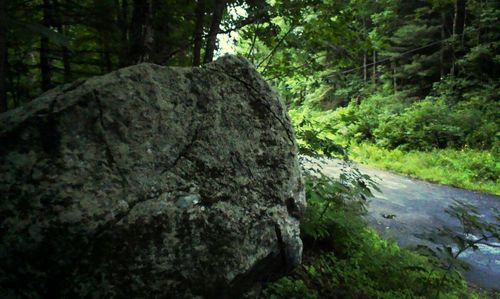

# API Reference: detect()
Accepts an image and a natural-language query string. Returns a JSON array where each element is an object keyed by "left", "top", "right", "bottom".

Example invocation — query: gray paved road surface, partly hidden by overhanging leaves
[{"left": 316, "top": 160, "right": 500, "bottom": 289}]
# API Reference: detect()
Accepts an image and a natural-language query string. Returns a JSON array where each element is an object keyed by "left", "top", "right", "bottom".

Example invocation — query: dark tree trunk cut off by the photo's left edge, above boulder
[{"left": 0, "top": 0, "right": 8, "bottom": 112}]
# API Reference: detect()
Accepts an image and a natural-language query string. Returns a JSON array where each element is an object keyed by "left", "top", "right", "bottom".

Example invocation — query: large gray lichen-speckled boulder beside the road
[{"left": 0, "top": 56, "right": 305, "bottom": 298}]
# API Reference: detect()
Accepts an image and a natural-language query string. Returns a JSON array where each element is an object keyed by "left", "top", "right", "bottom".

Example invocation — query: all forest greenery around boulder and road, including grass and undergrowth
[{"left": 0, "top": 0, "right": 500, "bottom": 298}]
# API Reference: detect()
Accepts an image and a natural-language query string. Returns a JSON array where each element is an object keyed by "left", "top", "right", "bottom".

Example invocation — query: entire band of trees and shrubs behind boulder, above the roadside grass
[{"left": 0, "top": 0, "right": 500, "bottom": 149}]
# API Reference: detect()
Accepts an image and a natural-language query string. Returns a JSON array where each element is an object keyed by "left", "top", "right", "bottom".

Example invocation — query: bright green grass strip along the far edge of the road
[{"left": 350, "top": 143, "right": 500, "bottom": 195}]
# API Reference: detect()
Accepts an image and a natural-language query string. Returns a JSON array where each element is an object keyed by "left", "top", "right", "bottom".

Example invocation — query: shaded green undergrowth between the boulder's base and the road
[{"left": 263, "top": 162, "right": 475, "bottom": 299}]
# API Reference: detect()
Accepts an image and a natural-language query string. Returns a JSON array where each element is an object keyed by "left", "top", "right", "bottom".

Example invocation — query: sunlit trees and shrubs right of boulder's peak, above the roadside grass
[{"left": 232, "top": 0, "right": 500, "bottom": 156}]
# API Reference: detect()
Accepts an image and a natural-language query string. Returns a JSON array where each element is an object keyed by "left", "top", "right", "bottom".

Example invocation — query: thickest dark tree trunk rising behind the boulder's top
[{"left": 128, "top": 0, "right": 154, "bottom": 64}]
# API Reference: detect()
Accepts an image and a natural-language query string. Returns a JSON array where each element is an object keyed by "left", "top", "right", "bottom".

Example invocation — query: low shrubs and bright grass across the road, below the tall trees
[{"left": 290, "top": 80, "right": 500, "bottom": 194}]
